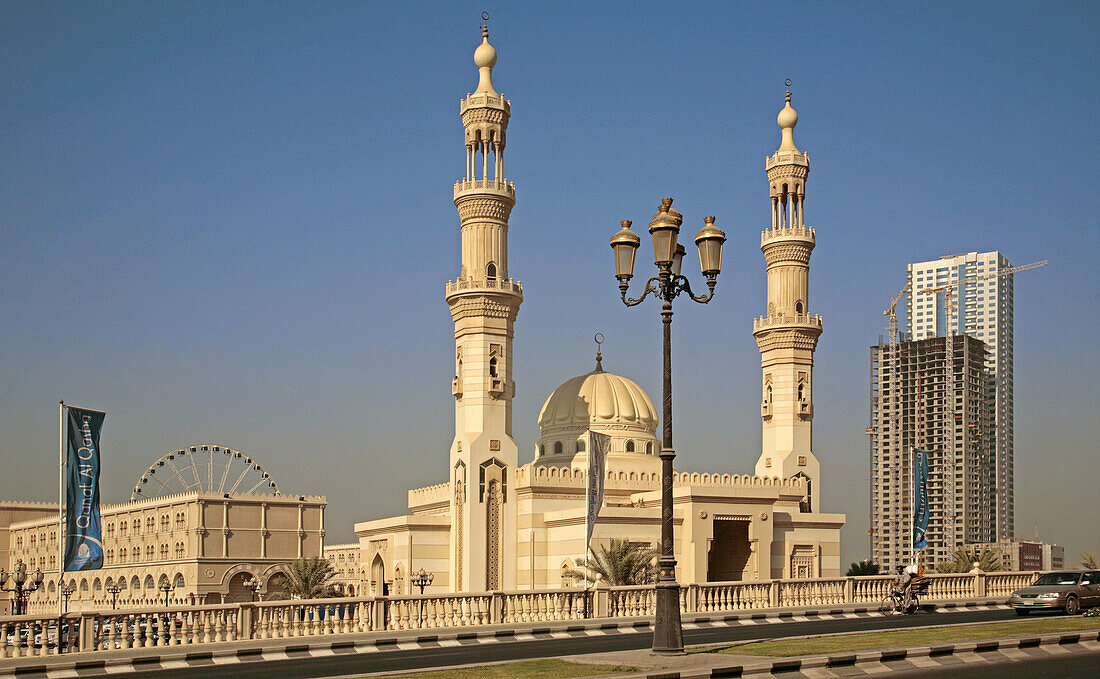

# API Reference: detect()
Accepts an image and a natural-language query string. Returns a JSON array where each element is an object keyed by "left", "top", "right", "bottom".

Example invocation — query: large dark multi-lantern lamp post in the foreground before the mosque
[{"left": 612, "top": 198, "right": 726, "bottom": 654}]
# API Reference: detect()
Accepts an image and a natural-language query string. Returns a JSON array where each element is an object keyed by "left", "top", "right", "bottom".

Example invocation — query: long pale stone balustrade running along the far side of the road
[{"left": 0, "top": 572, "right": 1040, "bottom": 658}]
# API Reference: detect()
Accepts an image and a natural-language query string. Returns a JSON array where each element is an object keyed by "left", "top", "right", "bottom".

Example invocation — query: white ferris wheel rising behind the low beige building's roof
[{"left": 130, "top": 445, "right": 279, "bottom": 502}]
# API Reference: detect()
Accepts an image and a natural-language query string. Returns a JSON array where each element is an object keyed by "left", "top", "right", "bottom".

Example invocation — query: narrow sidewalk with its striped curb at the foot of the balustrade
[{"left": 0, "top": 598, "right": 1005, "bottom": 679}]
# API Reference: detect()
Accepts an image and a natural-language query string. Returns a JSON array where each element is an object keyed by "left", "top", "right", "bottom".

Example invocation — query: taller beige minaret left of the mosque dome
[{"left": 447, "top": 25, "right": 524, "bottom": 592}]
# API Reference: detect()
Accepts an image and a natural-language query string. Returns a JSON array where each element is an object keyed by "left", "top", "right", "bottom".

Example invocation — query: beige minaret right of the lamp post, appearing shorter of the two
[{"left": 752, "top": 80, "right": 822, "bottom": 512}]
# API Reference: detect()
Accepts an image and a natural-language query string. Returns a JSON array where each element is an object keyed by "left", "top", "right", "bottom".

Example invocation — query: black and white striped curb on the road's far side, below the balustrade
[{"left": 0, "top": 602, "right": 1007, "bottom": 679}]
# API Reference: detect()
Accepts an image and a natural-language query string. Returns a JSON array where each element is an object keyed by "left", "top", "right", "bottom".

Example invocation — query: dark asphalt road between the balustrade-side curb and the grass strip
[{"left": 126, "top": 611, "right": 1015, "bottom": 679}]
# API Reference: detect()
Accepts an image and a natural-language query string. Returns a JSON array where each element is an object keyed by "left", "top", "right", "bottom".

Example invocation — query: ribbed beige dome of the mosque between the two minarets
[{"left": 539, "top": 365, "right": 658, "bottom": 435}]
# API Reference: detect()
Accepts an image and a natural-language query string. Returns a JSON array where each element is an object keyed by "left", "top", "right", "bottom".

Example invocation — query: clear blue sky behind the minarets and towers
[{"left": 0, "top": 1, "right": 1100, "bottom": 562}]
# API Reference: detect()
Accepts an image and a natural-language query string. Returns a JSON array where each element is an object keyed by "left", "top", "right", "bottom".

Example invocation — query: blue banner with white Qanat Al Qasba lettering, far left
[{"left": 62, "top": 406, "right": 105, "bottom": 571}]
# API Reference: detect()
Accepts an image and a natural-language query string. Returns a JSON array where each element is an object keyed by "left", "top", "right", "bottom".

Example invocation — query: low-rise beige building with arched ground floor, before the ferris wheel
[{"left": 0, "top": 492, "right": 327, "bottom": 613}]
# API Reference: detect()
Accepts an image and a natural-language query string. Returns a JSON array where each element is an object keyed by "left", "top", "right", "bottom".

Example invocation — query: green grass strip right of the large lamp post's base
[{"left": 693, "top": 616, "right": 1100, "bottom": 657}]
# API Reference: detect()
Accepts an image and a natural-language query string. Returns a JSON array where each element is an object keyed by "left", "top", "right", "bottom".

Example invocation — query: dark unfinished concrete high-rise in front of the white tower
[{"left": 869, "top": 335, "right": 996, "bottom": 566}]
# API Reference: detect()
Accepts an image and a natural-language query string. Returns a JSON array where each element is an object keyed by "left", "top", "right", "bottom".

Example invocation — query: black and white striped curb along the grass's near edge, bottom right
[{"left": 620, "top": 629, "right": 1100, "bottom": 679}]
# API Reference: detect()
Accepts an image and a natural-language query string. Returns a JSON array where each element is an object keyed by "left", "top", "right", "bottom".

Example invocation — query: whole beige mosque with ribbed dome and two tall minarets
[{"left": 352, "top": 28, "right": 845, "bottom": 594}]
